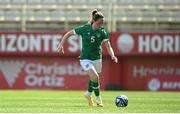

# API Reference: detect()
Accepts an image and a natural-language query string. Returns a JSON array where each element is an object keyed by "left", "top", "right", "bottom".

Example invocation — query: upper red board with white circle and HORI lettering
[{"left": 111, "top": 32, "right": 180, "bottom": 56}]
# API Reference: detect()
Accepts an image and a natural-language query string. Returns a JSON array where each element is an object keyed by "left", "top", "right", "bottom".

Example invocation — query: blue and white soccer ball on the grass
[{"left": 115, "top": 95, "right": 128, "bottom": 107}]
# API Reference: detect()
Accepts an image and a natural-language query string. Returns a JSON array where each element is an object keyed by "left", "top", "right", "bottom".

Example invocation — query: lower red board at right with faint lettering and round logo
[{"left": 123, "top": 57, "right": 180, "bottom": 91}]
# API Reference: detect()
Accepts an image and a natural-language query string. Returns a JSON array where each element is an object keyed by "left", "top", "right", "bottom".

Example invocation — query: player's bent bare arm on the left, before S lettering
[{"left": 57, "top": 30, "right": 74, "bottom": 53}]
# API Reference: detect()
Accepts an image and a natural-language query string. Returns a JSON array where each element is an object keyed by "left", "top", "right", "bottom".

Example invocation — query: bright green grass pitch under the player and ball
[{"left": 0, "top": 90, "right": 180, "bottom": 113}]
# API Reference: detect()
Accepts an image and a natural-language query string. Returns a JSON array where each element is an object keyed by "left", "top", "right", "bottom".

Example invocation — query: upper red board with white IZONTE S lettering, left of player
[{"left": 0, "top": 32, "right": 106, "bottom": 56}]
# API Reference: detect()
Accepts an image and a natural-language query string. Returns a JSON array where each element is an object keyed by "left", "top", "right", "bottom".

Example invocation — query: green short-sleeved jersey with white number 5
[{"left": 74, "top": 23, "right": 109, "bottom": 60}]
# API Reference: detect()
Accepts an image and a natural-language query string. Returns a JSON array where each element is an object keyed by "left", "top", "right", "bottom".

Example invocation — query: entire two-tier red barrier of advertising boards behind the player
[{"left": 0, "top": 32, "right": 180, "bottom": 91}]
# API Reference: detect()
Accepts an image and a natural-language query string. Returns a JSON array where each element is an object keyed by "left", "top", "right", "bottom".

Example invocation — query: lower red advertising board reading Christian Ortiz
[{"left": 0, "top": 57, "right": 107, "bottom": 90}]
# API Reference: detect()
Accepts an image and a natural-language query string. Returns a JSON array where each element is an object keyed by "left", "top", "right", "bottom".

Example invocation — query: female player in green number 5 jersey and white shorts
[{"left": 58, "top": 10, "right": 118, "bottom": 107}]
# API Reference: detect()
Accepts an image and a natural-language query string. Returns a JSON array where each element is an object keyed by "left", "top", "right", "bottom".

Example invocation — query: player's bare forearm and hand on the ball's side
[{"left": 104, "top": 40, "right": 118, "bottom": 63}]
